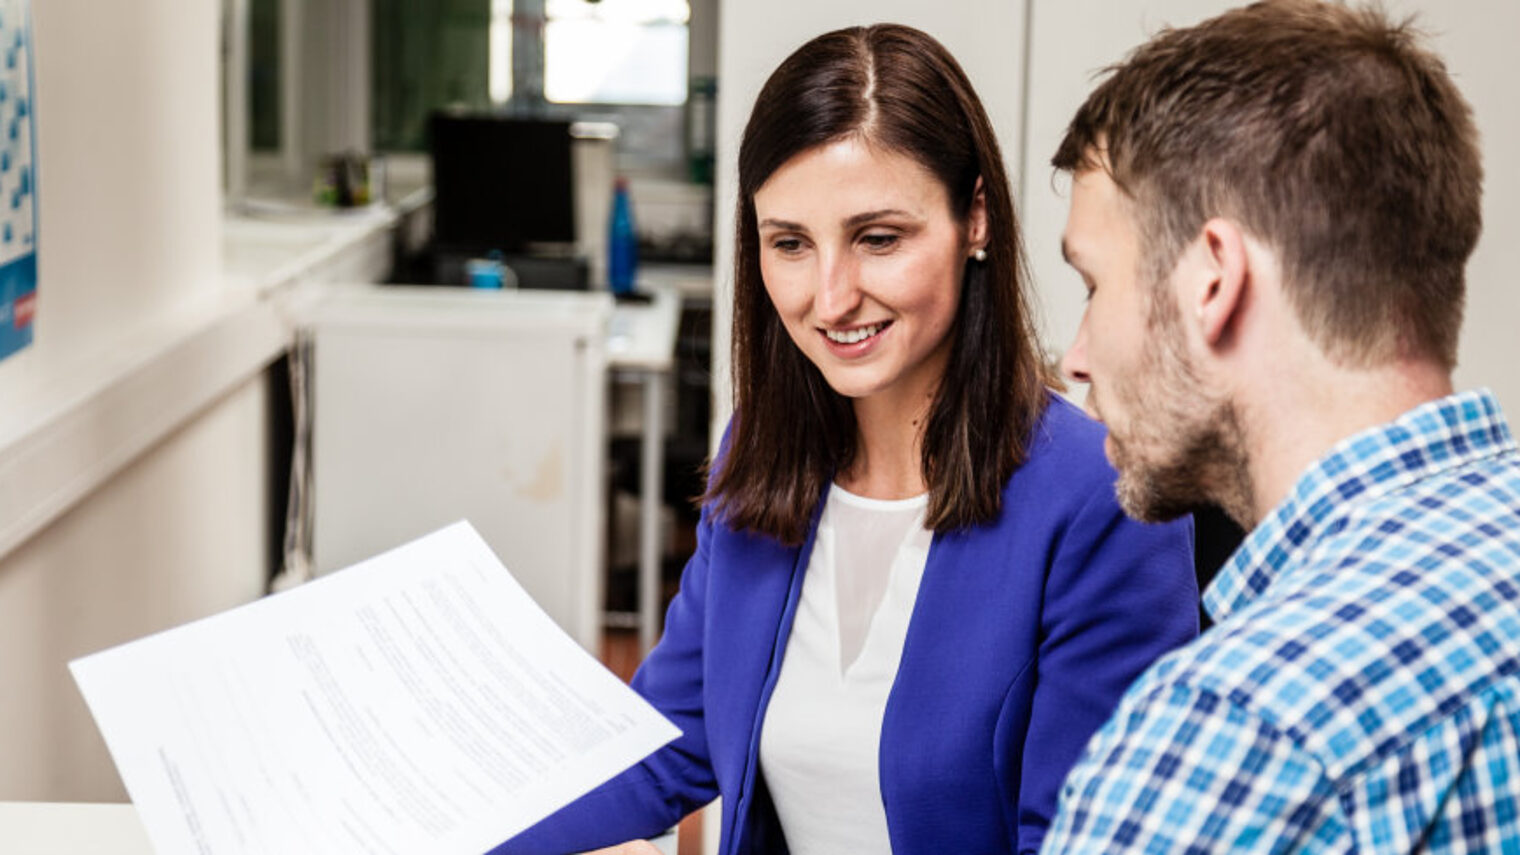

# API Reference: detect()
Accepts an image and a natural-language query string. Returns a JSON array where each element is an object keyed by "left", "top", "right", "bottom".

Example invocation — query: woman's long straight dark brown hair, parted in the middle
[{"left": 702, "top": 24, "right": 1046, "bottom": 545}]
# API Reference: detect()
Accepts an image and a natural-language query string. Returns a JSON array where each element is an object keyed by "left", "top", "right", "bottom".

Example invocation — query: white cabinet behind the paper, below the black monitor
[{"left": 310, "top": 286, "right": 613, "bottom": 654}]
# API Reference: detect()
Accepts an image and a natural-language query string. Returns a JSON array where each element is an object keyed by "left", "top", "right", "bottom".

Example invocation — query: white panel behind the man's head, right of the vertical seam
[{"left": 1023, "top": 0, "right": 1520, "bottom": 417}]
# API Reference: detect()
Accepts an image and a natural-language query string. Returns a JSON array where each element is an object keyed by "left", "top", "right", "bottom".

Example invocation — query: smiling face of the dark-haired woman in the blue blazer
[{"left": 755, "top": 137, "right": 986, "bottom": 406}]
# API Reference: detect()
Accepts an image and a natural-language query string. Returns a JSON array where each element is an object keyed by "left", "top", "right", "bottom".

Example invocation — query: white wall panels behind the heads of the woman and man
[{"left": 713, "top": 0, "right": 1520, "bottom": 425}]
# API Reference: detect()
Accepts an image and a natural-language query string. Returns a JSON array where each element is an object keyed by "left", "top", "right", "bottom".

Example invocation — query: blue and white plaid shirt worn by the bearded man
[{"left": 1044, "top": 393, "right": 1520, "bottom": 855}]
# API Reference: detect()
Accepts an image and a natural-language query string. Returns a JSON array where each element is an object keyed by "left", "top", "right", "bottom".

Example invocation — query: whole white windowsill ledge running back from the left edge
[{"left": 0, "top": 177, "right": 430, "bottom": 557}]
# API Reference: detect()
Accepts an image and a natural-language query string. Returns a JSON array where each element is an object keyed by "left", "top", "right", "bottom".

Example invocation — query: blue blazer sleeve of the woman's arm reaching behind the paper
[{"left": 489, "top": 499, "right": 717, "bottom": 855}]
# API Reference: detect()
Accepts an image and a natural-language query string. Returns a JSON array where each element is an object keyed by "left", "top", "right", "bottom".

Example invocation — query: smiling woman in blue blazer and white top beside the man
[{"left": 499, "top": 26, "right": 1196, "bottom": 855}]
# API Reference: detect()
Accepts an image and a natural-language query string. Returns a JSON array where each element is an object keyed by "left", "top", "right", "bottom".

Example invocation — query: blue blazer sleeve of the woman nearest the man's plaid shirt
[{"left": 1018, "top": 479, "right": 1198, "bottom": 853}]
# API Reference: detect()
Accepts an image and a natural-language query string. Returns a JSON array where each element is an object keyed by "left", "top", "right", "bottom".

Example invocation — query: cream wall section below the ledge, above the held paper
[{"left": 0, "top": 375, "right": 268, "bottom": 802}]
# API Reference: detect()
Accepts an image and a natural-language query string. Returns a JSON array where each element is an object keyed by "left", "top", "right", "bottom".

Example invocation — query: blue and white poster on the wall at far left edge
[{"left": 0, "top": 0, "right": 36, "bottom": 359}]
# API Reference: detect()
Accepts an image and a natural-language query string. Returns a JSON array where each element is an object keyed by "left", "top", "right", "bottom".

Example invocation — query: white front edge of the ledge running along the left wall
[{"left": 0, "top": 301, "right": 289, "bottom": 557}]
